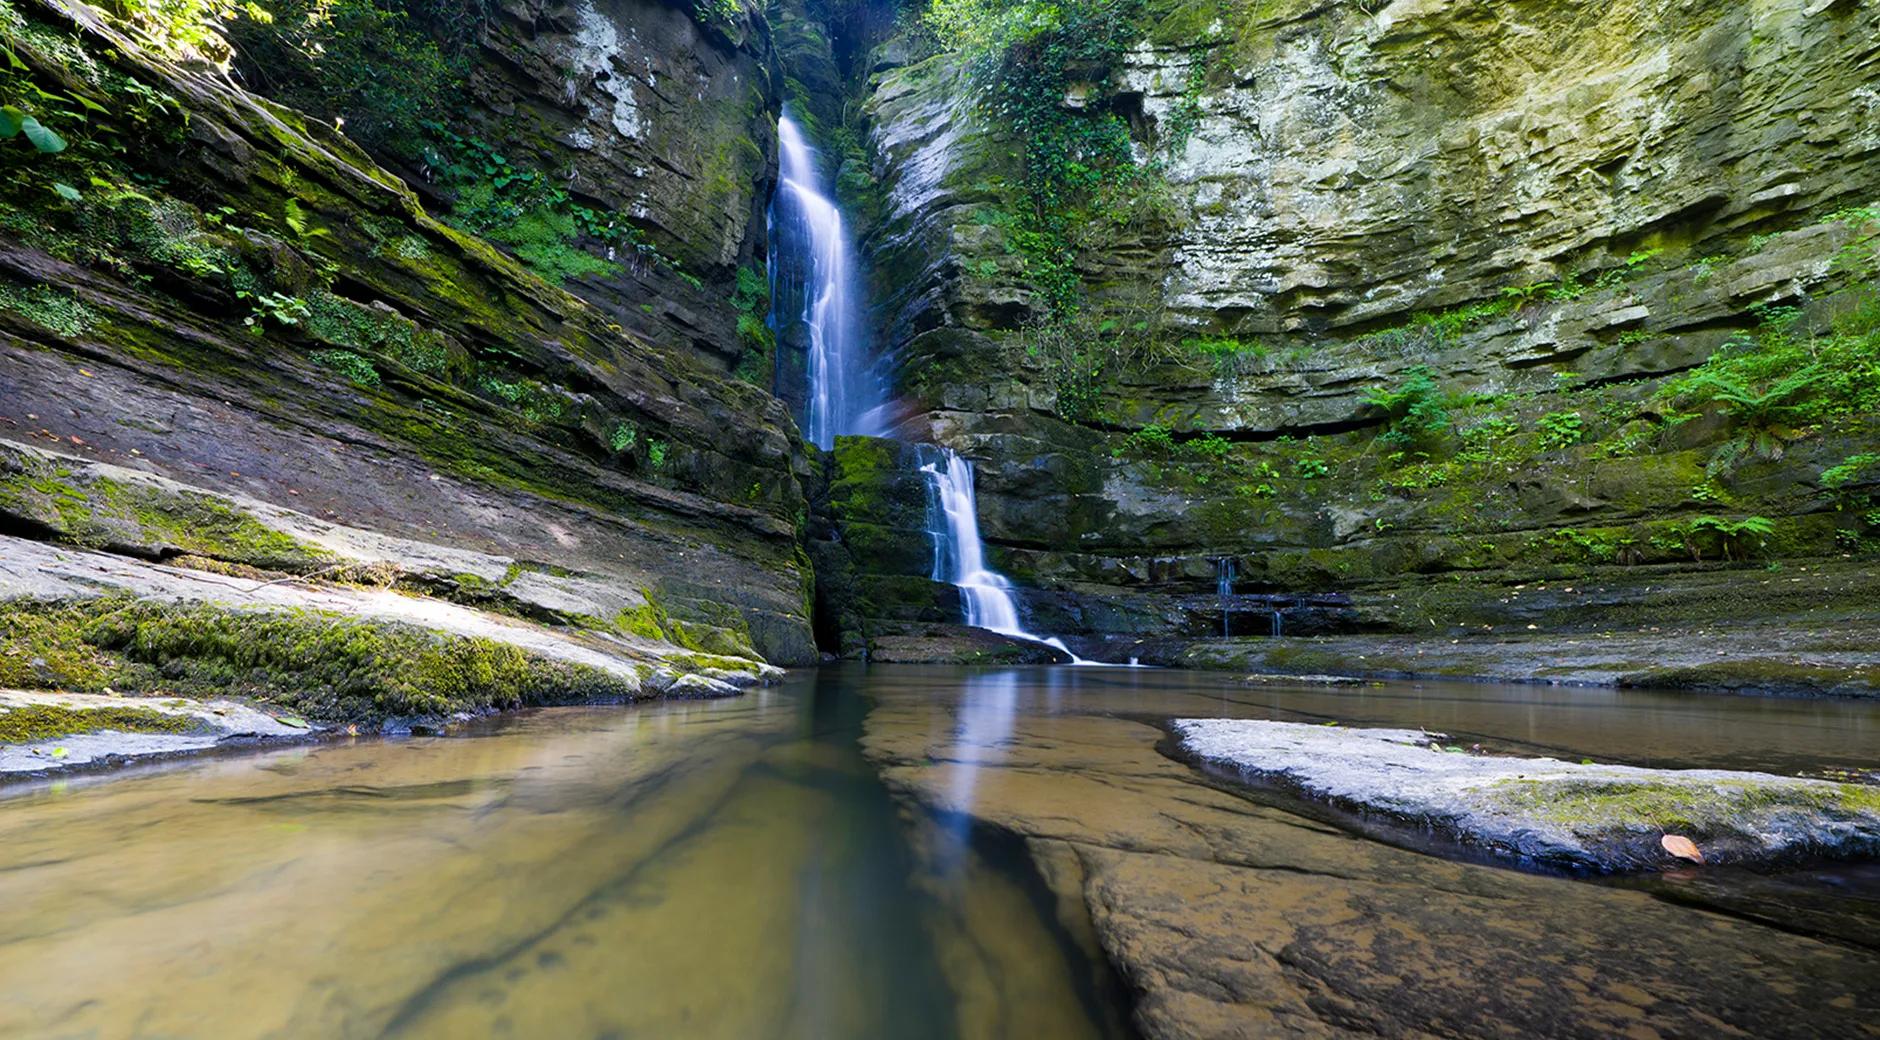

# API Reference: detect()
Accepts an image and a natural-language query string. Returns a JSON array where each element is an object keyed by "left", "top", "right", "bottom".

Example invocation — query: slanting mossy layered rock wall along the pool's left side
[{"left": 0, "top": 4, "right": 814, "bottom": 715}]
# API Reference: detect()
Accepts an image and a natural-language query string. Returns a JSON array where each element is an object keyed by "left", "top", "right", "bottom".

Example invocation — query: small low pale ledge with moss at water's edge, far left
[{"left": 0, "top": 690, "right": 316, "bottom": 780}]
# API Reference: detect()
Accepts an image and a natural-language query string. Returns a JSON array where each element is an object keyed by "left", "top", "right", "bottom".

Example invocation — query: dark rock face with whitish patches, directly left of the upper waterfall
[{"left": 468, "top": 0, "right": 776, "bottom": 365}]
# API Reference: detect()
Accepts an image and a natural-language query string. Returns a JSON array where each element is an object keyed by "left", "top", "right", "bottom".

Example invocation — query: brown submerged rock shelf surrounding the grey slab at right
[{"left": 865, "top": 671, "right": 1880, "bottom": 1038}]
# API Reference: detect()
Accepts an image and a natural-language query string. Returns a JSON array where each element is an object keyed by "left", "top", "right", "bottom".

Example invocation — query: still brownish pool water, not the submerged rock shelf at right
[{"left": 0, "top": 668, "right": 1880, "bottom": 1038}]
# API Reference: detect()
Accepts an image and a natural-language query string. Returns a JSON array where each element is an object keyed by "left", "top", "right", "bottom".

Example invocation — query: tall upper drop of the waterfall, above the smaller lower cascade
[{"left": 771, "top": 111, "right": 885, "bottom": 449}]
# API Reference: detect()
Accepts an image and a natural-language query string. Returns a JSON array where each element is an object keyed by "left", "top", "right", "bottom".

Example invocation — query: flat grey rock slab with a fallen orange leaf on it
[{"left": 1173, "top": 718, "right": 1880, "bottom": 873}]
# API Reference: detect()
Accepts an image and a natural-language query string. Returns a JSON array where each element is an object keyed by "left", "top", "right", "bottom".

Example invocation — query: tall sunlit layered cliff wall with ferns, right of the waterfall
[{"left": 827, "top": 0, "right": 1880, "bottom": 646}]
